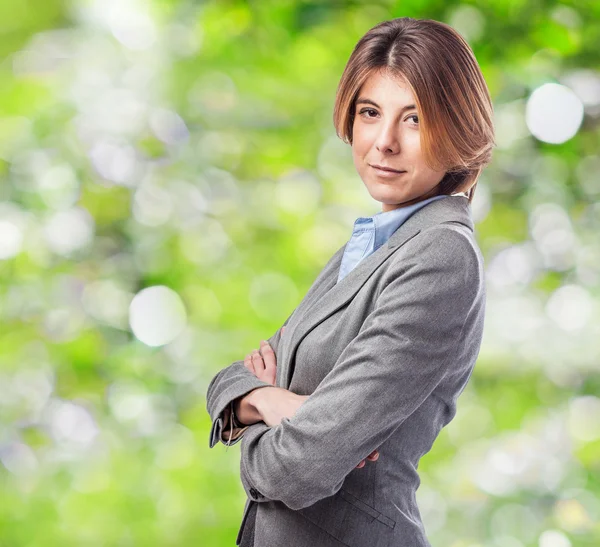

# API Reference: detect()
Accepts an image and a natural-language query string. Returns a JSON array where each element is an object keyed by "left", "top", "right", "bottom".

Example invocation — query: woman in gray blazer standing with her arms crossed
[{"left": 207, "top": 18, "right": 494, "bottom": 547}]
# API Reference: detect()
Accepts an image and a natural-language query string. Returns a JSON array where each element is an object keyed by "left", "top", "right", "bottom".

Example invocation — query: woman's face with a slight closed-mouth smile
[{"left": 352, "top": 71, "right": 445, "bottom": 212}]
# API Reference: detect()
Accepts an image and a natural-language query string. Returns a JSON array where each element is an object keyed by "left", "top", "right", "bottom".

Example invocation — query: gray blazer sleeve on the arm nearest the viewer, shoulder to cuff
[{"left": 240, "top": 224, "right": 485, "bottom": 510}]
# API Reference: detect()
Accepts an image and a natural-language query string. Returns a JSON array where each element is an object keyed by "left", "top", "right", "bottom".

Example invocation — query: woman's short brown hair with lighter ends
[{"left": 333, "top": 17, "right": 495, "bottom": 206}]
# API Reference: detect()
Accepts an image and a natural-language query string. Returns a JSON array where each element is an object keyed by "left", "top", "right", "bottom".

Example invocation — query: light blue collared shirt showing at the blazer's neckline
[{"left": 337, "top": 195, "right": 449, "bottom": 283}]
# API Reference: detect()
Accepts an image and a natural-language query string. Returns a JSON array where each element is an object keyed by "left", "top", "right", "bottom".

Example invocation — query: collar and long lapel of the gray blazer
[{"left": 277, "top": 195, "right": 474, "bottom": 389}]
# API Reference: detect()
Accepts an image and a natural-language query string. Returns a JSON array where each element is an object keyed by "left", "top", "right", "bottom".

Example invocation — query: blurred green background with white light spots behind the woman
[{"left": 0, "top": 0, "right": 600, "bottom": 547}]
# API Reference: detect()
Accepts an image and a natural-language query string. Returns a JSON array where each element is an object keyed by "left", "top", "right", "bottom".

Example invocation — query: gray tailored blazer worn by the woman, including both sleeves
[{"left": 207, "top": 195, "right": 485, "bottom": 547}]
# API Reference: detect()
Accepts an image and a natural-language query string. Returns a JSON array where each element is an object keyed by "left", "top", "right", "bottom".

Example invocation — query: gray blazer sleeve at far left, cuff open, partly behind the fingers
[{"left": 206, "top": 312, "right": 293, "bottom": 448}]
